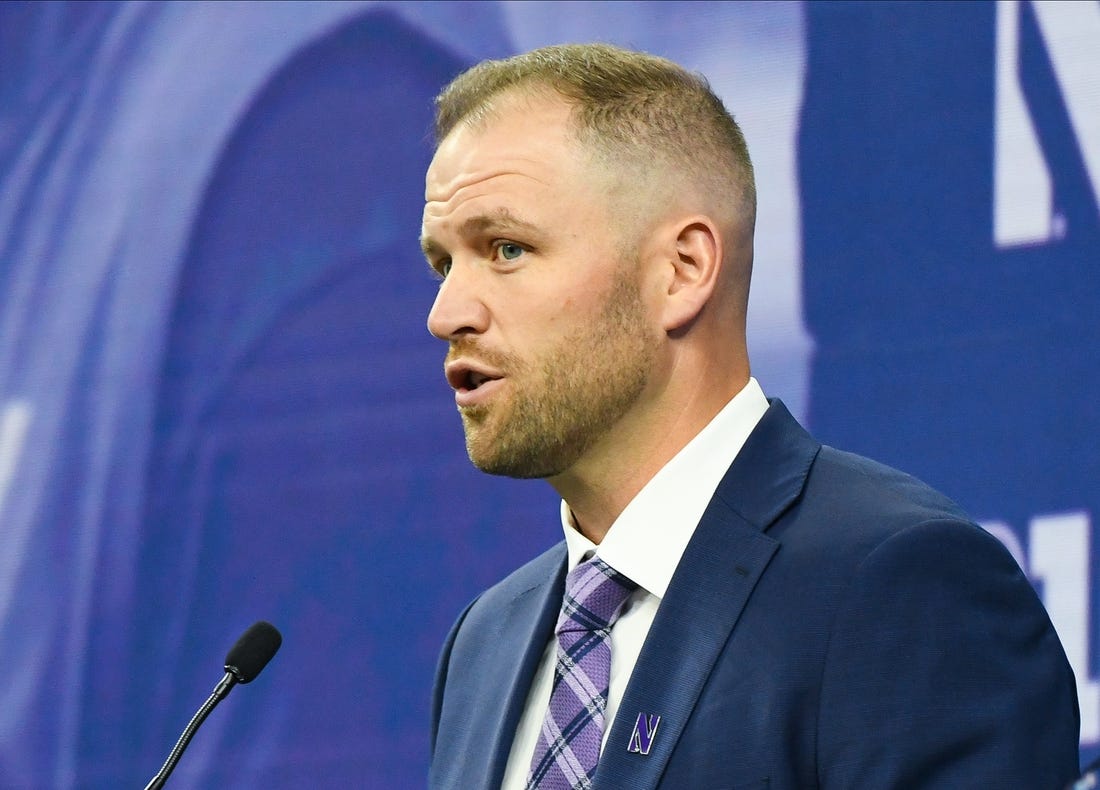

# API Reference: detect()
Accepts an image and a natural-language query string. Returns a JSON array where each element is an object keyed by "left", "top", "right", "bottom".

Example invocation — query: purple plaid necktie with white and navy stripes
[{"left": 527, "top": 557, "right": 638, "bottom": 790}]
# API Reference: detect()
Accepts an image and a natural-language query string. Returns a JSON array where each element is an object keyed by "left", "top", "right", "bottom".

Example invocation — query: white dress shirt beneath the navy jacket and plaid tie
[{"left": 502, "top": 378, "right": 768, "bottom": 790}]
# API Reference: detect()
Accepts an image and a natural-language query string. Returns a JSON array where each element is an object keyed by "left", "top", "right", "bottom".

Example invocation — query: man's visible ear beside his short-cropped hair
[{"left": 661, "top": 216, "right": 724, "bottom": 332}]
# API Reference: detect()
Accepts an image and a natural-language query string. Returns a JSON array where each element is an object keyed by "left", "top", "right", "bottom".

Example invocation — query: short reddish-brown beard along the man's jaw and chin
[{"left": 460, "top": 262, "right": 656, "bottom": 479}]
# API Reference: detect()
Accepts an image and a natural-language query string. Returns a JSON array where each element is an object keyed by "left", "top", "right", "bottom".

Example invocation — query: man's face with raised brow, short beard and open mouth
[{"left": 422, "top": 91, "right": 656, "bottom": 478}]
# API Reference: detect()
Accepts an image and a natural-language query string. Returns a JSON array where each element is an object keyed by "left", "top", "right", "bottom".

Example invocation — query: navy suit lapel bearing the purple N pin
[{"left": 594, "top": 401, "right": 820, "bottom": 790}]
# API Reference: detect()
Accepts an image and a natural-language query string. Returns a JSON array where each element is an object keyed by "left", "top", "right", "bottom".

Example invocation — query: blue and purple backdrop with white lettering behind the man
[{"left": 0, "top": 1, "right": 1100, "bottom": 789}]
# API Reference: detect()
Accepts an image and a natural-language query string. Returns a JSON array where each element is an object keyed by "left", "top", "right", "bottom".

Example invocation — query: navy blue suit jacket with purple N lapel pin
[{"left": 430, "top": 402, "right": 1079, "bottom": 790}]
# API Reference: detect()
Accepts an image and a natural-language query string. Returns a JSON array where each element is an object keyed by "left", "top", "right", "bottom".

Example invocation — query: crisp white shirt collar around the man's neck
[{"left": 561, "top": 378, "right": 768, "bottom": 599}]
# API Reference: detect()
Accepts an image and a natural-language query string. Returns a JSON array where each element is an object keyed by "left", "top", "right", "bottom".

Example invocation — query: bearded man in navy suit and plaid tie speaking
[{"left": 422, "top": 45, "right": 1078, "bottom": 790}]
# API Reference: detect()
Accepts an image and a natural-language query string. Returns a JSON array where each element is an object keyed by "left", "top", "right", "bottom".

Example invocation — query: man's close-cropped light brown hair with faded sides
[{"left": 435, "top": 44, "right": 756, "bottom": 228}]
